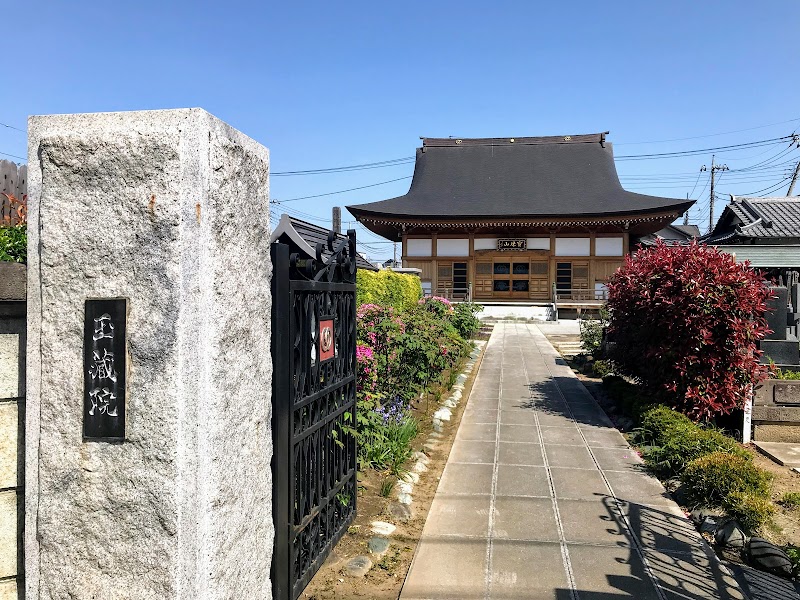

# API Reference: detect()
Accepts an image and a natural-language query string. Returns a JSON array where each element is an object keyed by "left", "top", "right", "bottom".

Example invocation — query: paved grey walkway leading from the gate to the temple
[{"left": 400, "top": 323, "right": 744, "bottom": 600}]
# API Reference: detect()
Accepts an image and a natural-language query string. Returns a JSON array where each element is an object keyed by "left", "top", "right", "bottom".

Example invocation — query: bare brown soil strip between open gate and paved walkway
[{"left": 300, "top": 335, "right": 488, "bottom": 600}]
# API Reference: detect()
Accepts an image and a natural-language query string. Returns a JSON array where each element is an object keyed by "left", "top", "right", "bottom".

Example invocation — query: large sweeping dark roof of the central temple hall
[{"left": 347, "top": 134, "right": 693, "bottom": 219}]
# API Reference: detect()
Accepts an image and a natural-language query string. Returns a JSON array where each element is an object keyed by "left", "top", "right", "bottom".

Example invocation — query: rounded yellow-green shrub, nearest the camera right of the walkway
[{"left": 681, "top": 452, "right": 772, "bottom": 511}]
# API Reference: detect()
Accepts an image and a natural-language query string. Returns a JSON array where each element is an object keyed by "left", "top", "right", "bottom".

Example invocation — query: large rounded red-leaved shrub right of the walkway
[{"left": 608, "top": 242, "right": 770, "bottom": 420}]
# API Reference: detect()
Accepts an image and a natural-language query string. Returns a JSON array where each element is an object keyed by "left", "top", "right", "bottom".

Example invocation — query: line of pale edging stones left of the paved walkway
[{"left": 344, "top": 340, "right": 486, "bottom": 577}]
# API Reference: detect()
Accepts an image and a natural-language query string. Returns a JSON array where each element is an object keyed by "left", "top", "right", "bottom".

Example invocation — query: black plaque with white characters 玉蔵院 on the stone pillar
[{"left": 83, "top": 299, "right": 127, "bottom": 441}]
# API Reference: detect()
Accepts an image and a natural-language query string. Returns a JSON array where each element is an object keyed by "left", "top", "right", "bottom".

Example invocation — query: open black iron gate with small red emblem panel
[{"left": 271, "top": 230, "right": 356, "bottom": 600}]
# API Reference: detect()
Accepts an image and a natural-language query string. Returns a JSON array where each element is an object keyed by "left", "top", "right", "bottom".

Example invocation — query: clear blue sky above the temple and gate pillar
[{"left": 0, "top": 0, "right": 800, "bottom": 257}]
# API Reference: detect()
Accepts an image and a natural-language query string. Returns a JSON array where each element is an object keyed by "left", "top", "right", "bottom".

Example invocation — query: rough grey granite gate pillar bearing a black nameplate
[{"left": 25, "top": 109, "right": 273, "bottom": 600}]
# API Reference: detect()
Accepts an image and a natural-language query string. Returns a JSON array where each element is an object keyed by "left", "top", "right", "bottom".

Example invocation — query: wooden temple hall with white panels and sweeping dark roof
[{"left": 347, "top": 133, "right": 693, "bottom": 305}]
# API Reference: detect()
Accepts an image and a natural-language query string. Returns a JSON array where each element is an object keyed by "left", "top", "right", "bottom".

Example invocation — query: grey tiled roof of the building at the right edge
[{"left": 706, "top": 196, "right": 800, "bottom": 243}]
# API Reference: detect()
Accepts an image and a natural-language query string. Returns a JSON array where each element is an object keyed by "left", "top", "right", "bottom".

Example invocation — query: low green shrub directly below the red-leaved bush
[{"left": 635, "top": 406, "right": 750, "bottom": 477}]
